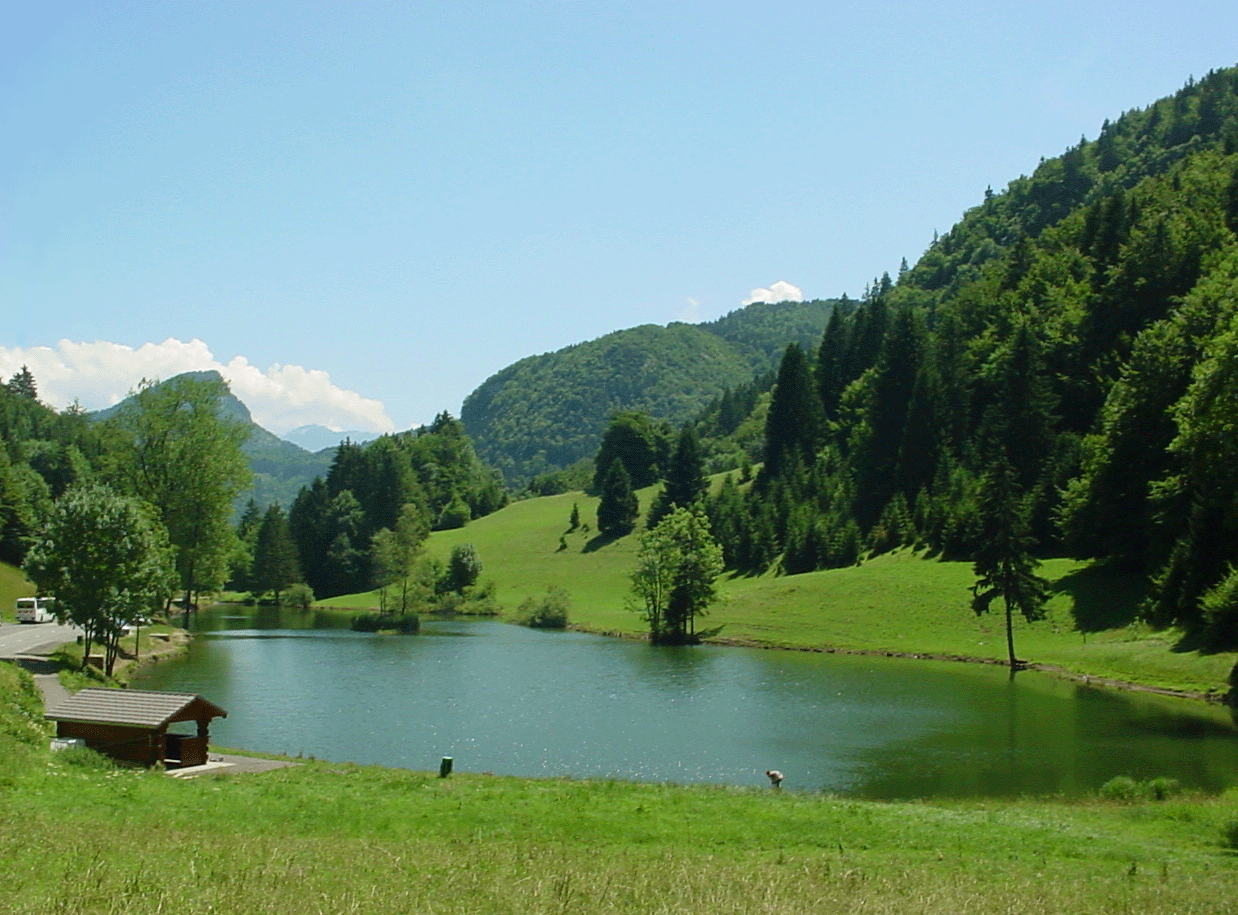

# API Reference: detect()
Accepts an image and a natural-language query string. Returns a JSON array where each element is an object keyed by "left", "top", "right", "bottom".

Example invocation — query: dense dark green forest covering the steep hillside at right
[{"left": 599, "top": 69, "right": 1238, "bottom": 648}]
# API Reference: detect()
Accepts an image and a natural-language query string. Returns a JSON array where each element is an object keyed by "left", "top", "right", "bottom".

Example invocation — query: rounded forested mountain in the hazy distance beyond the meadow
[{"left": 461, "top": 301, "right": 846, "bottom": 482}]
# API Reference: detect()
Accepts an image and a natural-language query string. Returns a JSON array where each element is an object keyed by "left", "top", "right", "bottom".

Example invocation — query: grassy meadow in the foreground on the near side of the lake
[{"left": 0, "top": 664, "right": 1238, "bottom": 915}]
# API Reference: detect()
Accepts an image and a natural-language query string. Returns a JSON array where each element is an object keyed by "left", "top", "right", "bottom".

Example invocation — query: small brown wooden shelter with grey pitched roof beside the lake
[{"left": 47, "top": 690, "right": 228, "bottom": 768}]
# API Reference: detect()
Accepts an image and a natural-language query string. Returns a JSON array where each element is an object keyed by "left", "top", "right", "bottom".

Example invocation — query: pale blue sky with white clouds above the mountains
[{"left": 0, "top": 0, "right": 1238, "bottom": 432}]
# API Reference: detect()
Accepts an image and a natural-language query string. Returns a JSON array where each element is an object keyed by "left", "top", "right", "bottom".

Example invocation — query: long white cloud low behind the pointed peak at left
[{"left": 0, "top": 337, "right": 395, "bottom": 433}]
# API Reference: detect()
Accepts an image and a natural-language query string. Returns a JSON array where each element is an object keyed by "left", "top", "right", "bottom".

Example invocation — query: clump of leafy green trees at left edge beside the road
[{"left": 0, "top": 369, "right": 250, "bottom": 674}]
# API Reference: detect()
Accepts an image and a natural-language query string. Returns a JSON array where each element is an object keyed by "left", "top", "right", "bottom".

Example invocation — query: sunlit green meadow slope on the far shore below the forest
[{"left": 324, "top": 488, "right": 1238, "bottom": 695}]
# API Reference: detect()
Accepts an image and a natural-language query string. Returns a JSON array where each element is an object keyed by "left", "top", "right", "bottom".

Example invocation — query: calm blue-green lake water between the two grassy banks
[{"left": 134, "top": 608, "right": 1238, "bottom": 799}]
